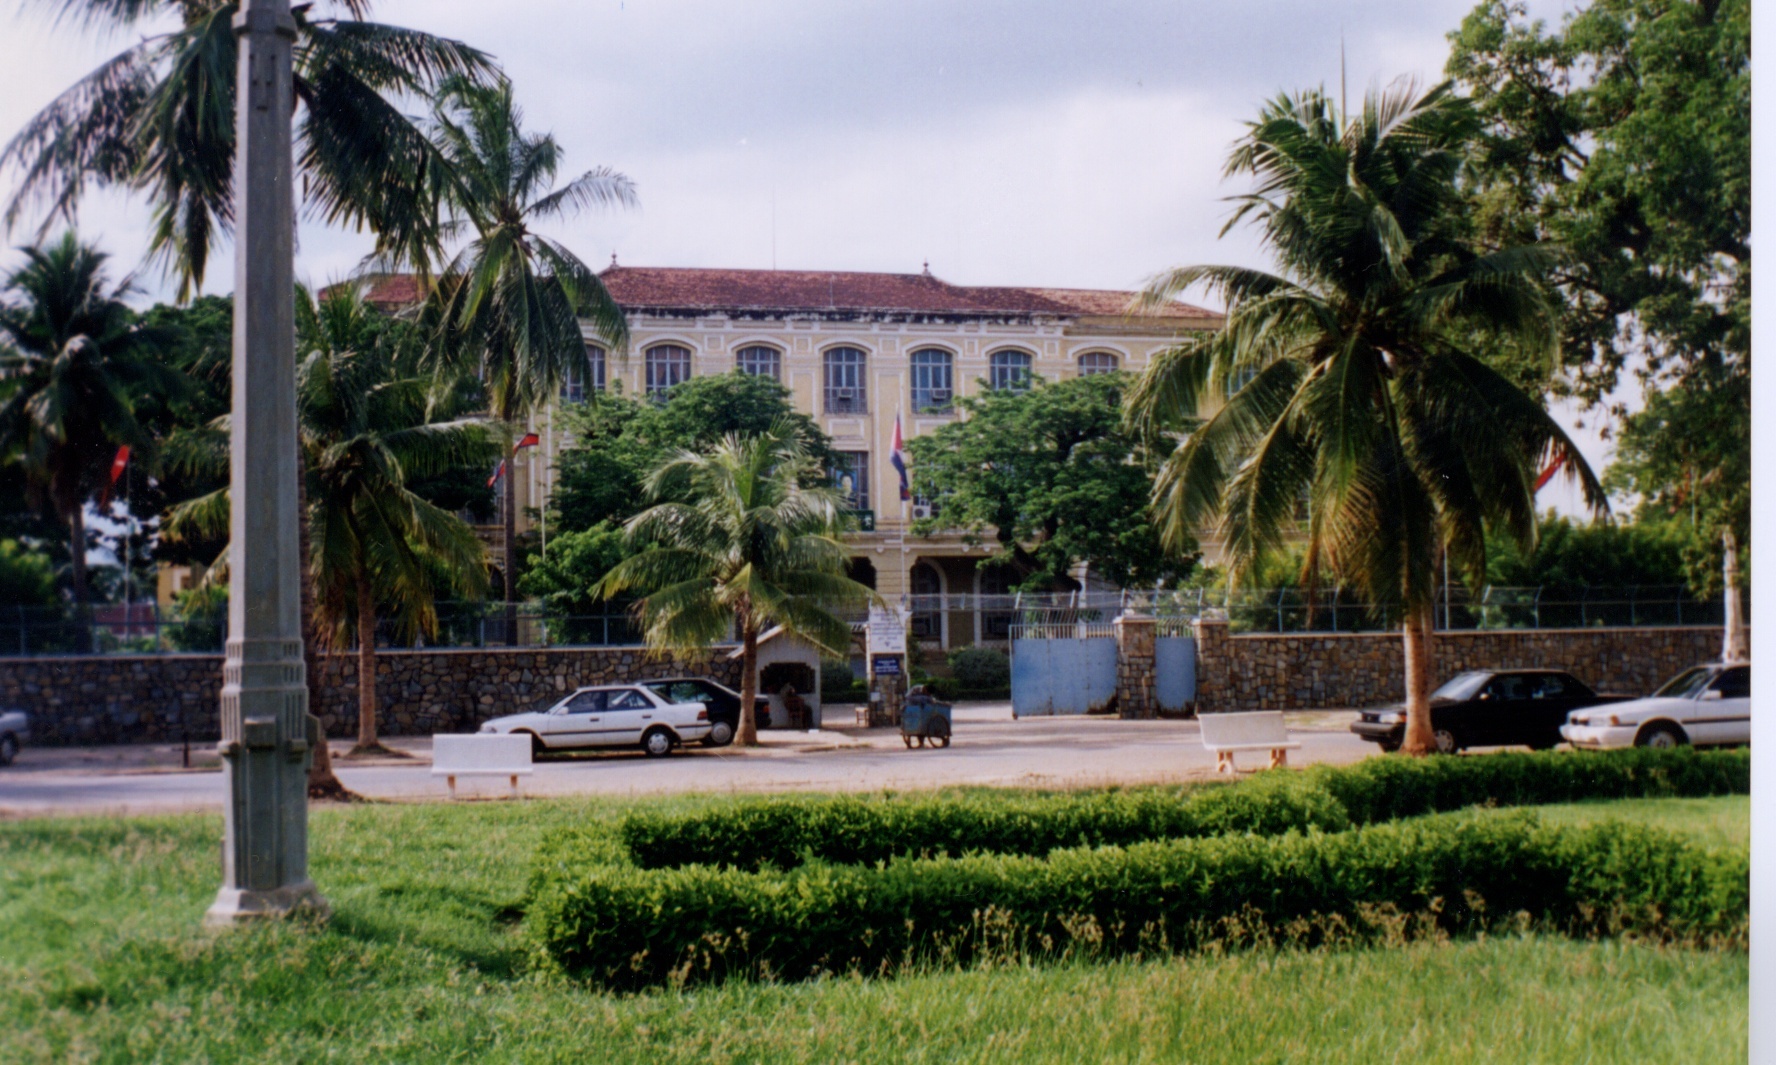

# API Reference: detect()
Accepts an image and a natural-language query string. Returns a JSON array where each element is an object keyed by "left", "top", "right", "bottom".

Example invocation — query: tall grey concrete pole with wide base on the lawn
[{"left": 204, "top": 0, "right": 327, "bottom": 925}]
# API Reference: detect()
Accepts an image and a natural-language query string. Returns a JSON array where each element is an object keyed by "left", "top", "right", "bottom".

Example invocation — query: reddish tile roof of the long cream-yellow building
[{"left": 351, "top": 266, "right": 1218, "bottom": 323}]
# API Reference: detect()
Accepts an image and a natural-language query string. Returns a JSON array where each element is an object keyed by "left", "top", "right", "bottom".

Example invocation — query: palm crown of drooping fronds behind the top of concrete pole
[{"left": 0, "top": 0, "right": 494, "bottom": 300}]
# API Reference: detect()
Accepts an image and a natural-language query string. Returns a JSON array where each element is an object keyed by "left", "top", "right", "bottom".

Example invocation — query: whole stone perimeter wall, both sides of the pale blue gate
[{"left": 0, "top": 621, "right": 1721, "bottom": 746}]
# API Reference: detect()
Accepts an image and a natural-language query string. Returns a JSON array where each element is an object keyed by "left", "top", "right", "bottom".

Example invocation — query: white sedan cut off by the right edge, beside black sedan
[{"left": 1559, "top": 664, "right": 1751, "bottom": 751}]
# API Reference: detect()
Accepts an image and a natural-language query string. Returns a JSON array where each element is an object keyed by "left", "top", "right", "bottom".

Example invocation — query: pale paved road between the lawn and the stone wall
[{"left": 0, "top": 705, "right": 1375, "bottom": 817}]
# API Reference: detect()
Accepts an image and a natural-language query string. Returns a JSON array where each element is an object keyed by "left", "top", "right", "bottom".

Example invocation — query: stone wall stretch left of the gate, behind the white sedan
[{"left": 0, "top": 648, "right": 741, "bottom": 746}]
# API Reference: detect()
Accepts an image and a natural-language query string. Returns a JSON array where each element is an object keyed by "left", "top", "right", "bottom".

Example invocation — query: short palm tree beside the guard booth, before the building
[{"left": 593, "top": 422, "right": 876, "bottom": 747}]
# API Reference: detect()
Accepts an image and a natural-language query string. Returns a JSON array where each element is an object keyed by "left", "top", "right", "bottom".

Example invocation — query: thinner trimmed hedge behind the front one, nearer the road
[{"left": 620, "top": 747, "right": 1751, "bottom": 870}]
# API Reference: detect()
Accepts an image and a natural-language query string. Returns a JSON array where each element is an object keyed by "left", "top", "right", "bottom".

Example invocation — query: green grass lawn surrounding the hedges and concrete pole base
[{"left": 0, "top": 797, "right": 1749, "bottom": 1063}]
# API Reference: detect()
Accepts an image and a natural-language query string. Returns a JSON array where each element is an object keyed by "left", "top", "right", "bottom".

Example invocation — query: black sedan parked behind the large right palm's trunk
[{"left": 1350, "top": 669, "right": 1632, "bottom": 754}]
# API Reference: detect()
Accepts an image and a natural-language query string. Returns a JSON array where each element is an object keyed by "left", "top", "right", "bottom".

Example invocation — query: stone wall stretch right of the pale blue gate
[{"left": 1197, "top": 621, "right": 1721, "bottom": 714}]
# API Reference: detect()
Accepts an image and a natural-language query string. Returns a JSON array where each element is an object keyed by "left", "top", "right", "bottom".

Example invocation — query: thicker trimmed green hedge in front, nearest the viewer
[{"left": 529, "top": 811, "right": 1749, "bottom": 989}]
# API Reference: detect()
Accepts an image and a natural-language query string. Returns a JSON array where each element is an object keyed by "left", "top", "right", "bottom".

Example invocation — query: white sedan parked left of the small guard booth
[{"left": 481, "top": 683, "right": 709, "bottom": 758}]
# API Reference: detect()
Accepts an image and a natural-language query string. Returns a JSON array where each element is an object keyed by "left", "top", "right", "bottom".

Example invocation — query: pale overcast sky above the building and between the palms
[{"left": 0, "top": 0, "right": 1604, "bottom": 514}]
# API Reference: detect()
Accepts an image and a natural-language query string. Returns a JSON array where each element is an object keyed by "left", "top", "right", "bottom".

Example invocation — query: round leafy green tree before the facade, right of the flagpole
[{"left": 908, "top": 375, "right": 1195, "bottom": 588}]
